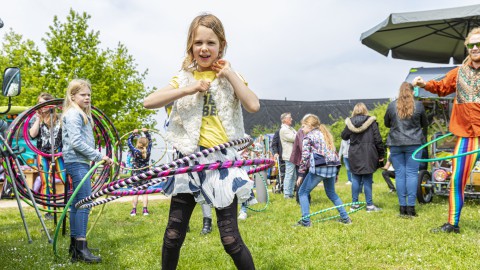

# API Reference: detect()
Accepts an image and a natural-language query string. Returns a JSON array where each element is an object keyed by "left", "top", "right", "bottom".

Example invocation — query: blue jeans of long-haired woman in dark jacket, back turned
[{"left": 390, "top": 145, "right": 420, "bottom": 206}]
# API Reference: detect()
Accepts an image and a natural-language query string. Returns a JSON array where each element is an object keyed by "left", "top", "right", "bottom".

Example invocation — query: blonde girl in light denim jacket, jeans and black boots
[{"left": 61, "top": 79, "right": 113, "bottom": 263}]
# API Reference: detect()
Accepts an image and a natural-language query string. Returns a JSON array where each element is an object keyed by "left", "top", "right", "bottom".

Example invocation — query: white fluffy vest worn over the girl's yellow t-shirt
[{"left": 166, "top": 70, "right": 245, "bottom": 155}]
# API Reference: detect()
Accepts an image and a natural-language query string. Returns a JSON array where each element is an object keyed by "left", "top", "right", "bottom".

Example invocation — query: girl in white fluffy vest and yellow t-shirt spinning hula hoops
[{"left": 144, "top": 14, "right": 260, "bottom": 269}]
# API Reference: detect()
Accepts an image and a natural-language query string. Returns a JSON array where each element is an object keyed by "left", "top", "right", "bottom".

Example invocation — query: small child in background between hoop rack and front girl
[{"left": 128, "top": 128, "right": 152, "bottom": 217}]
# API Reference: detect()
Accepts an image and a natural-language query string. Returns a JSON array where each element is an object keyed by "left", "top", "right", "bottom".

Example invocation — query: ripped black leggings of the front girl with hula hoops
[{"left": 162, "top": 193, "right": 255, "bottom": 270}]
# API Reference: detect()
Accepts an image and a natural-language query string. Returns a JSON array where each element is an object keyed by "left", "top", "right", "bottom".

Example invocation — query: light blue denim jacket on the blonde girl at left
[{"left": 62, "top": 108, "right": 103, "bottom": 164}]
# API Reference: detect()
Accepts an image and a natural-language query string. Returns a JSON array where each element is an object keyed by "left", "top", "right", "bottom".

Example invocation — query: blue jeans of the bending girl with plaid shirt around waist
[{"left": 298, "top": 173, "right": 348, "bottom": 223}]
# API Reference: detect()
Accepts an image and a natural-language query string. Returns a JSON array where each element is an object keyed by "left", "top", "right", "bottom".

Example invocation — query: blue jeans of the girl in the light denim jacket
[{"left": 65, "top": 162, "right": 92, "bottom": 238}]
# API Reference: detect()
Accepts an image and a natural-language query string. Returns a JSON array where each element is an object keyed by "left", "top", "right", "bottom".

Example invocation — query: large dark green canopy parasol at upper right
[{"left": 360, "top": 5, "right": 480, "bottom": 64}]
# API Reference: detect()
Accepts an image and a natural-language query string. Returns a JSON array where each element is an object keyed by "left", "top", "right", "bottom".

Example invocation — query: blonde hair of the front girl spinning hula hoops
[{"left": 182, "top": 13, "right": 227, "bottom": 71}]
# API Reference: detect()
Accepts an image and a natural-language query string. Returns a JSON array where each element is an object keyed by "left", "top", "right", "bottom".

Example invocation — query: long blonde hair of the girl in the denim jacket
[{"left": 62, "top": 79, "right": 93, "bottom": 126}]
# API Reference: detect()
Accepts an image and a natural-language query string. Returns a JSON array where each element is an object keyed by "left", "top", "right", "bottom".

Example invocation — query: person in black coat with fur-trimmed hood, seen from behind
[{"left": 342, "top": 102, "right": 385, "bottom": 212}]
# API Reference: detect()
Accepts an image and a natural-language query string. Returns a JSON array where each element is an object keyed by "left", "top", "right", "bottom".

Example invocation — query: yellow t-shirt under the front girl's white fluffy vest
[{"left": 168, "top": 71, "right": 228, "bottom": 148}]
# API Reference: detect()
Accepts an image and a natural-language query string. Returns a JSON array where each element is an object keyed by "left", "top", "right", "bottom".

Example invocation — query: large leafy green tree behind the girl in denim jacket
[{"left": 43, "top": 10, "right": 155, "bottom": 134}]
